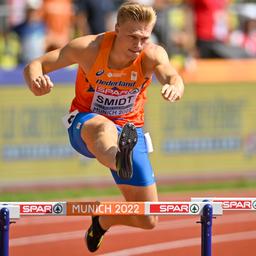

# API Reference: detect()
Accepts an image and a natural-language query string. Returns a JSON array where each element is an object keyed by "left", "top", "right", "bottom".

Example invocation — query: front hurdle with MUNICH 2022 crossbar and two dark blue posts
[{"left": 0, "top": 201, "right": 223, "bottom": 256}]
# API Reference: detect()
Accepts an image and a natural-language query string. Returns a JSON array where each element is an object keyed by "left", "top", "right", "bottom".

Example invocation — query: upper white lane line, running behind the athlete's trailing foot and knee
[{"left": 10, "top": 213, "right": 256, "bottom": 247}]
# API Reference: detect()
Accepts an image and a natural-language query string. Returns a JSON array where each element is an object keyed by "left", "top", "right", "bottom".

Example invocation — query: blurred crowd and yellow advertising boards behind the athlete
[{"left": 0, "top": 0, "right": 256, "bottom": 197}]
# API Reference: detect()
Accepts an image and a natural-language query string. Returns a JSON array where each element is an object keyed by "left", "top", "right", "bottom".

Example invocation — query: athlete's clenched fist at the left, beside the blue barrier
[{"left": 30, "top": 75, "right": 54, "bottom": 96}]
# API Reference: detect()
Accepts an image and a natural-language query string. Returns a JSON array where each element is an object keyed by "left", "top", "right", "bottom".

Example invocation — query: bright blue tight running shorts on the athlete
[{"left": 68, "top": 113, "right": 155, "bottom": 186}]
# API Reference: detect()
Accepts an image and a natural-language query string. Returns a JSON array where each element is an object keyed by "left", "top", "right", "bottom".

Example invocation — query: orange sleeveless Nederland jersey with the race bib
[{"left": 70, "top": 32, "right": 151, "bottom": 127}]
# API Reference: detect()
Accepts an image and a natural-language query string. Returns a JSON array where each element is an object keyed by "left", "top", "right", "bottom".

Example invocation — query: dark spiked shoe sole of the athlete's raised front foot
[{"left": 118, "top": 123, "right": 138, "bottom": 180}]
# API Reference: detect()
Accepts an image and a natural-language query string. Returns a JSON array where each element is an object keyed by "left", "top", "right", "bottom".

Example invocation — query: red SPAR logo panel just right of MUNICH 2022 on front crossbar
[{"left": 150, "top": 203, "right": 189, "bottom": 214}]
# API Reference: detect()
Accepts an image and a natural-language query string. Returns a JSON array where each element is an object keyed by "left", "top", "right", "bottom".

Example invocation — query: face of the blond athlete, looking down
[{"left": 116, "top": 21, "right": 154, "bottom": 58}]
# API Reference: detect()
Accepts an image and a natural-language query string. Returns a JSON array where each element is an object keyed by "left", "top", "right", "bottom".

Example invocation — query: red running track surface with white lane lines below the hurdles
[{"left": 10, "top": 194, "right": 256, "bottom": 256}]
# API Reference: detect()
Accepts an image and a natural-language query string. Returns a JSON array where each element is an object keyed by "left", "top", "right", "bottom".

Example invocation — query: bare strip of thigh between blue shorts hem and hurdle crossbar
[{"left": 117, "top": 183, "right": 158, "bottom": 202}]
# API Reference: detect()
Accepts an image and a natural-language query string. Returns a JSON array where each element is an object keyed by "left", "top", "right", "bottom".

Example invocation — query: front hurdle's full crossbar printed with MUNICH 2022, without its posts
[{"left": 0, "top": 202, "right": 223, "bottom": 219}]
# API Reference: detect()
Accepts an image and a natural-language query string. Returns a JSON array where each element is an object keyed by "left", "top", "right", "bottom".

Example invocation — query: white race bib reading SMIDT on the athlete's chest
[{"left": 91, "top": 86, "right": 140, "bottom": 116}]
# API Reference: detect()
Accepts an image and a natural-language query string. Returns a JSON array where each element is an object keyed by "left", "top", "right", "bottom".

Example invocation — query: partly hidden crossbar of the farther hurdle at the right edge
[{"left": 191, "top": 197, "right": 256, "bottom": 211}]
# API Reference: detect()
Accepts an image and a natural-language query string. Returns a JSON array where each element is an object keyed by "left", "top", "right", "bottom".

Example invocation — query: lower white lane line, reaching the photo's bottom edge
[{"left": 99, "top": 231, "right": 256, "bottom": 256}]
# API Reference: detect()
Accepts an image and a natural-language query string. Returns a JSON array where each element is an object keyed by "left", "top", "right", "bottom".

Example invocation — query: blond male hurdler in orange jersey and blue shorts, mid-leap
[{"left": 24, "top": 2, "right": 184, "bottom": 252}]
